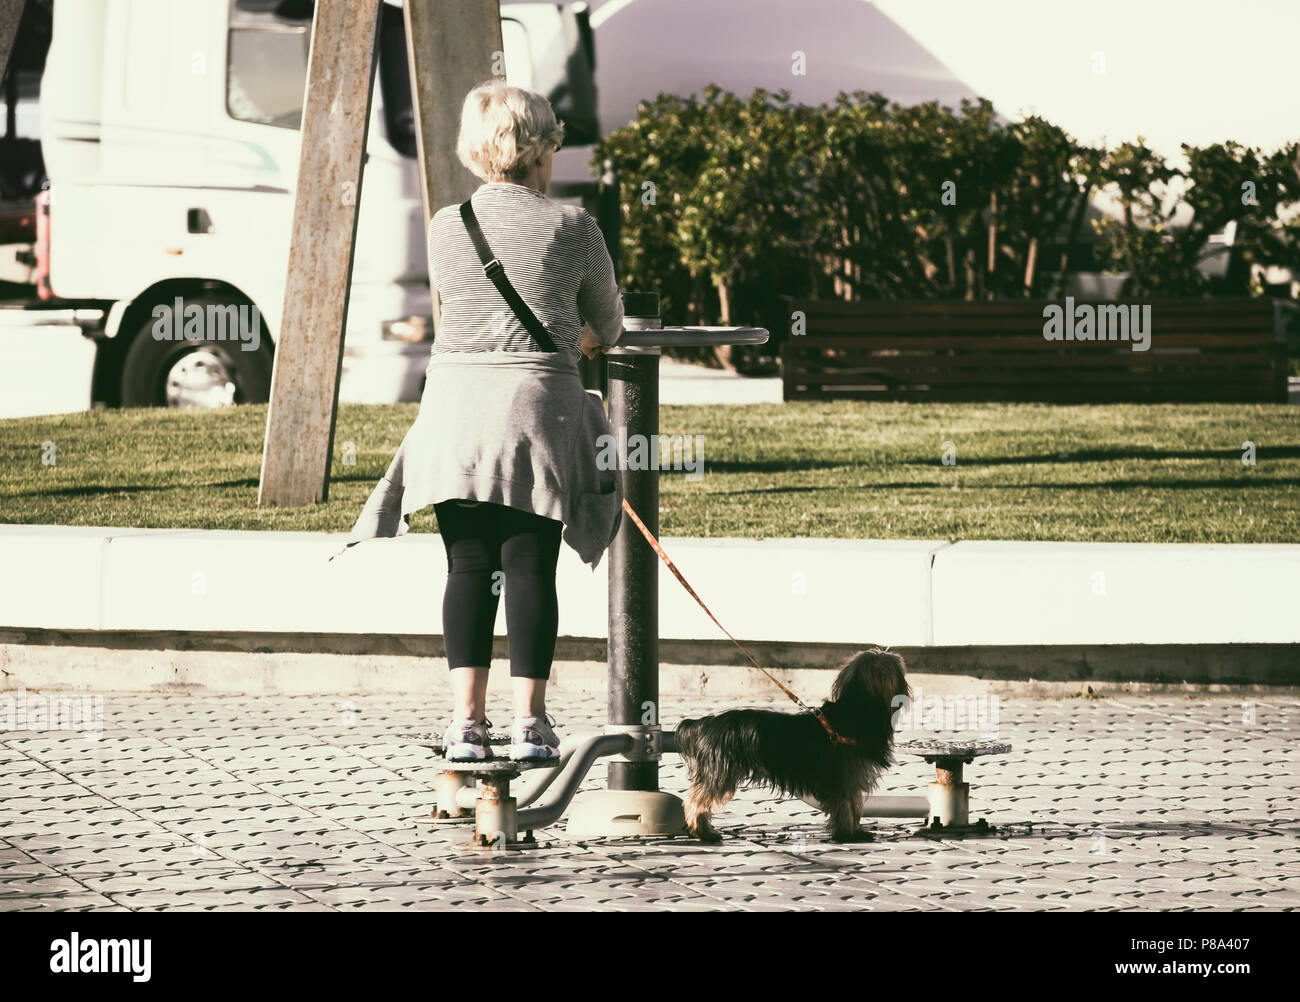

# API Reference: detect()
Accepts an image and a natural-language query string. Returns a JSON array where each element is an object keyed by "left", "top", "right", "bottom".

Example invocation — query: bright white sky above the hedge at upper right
[{"left": 868, "top": 0, "right": 1300, "bottom": 160}]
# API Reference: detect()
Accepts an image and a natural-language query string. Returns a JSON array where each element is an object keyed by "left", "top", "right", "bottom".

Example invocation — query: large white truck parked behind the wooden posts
[{"left": 0, "top": 0, "right": 608, "bottom": 417}]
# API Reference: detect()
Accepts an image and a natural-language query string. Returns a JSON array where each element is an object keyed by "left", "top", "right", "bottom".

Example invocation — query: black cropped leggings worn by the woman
[{"left": 433, "top": 500, "right": 564, "bottom": 678}]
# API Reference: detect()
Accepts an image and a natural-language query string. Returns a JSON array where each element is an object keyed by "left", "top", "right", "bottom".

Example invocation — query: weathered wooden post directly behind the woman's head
[{"left": 406, "top": 0, "right": 506, "bottom": 337}]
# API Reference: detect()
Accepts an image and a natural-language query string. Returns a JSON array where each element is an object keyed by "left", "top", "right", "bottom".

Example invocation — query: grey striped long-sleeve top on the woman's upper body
[{"left": 429, "top": 182, "right": 623, "bottom": 357}]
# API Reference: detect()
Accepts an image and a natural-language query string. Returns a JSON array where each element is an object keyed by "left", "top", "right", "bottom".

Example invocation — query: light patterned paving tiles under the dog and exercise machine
[{"left": 0, "top": 694, "right": 1300, "bottom": 911}]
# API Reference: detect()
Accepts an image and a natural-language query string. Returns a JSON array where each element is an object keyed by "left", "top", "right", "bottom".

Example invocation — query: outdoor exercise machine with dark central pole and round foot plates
[{"left": 406, "top": 292, "right": 1010, "bottom": 849}]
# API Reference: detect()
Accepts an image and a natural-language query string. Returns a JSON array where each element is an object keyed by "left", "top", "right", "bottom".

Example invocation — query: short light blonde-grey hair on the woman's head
[{"left": 456, "top": 79, "right": 564, "bottom": 182}]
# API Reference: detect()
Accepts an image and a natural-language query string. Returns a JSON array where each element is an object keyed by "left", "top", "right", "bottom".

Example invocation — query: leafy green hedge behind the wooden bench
[{"left": 594, "top": 86, "right": 1300, "bottom": 363}]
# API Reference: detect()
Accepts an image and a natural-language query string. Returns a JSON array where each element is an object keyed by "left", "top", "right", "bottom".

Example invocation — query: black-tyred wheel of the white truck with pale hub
[{"left": 122, "top": 296, "right": 273, "bottom": 407}]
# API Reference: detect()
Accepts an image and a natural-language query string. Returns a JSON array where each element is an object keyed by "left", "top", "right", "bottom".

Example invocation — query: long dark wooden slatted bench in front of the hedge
[{"left": 781, "top": 298, "right": 1287, "bottom": 403}]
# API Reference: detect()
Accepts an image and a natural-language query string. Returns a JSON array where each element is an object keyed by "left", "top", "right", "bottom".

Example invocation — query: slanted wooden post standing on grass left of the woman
[{"left": 257, "top": 0, "right": 381, "bottom": 506}]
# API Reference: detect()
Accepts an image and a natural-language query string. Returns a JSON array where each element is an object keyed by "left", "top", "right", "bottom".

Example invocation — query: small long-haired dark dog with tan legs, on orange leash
[{"left": 676, "top": 647, "right": 911, "bottom": 842}]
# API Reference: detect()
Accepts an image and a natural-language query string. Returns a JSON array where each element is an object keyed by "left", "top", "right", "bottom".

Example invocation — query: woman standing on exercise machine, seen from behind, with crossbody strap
[{"left": 350, "top": 81, "right": 623, "bottom": 760}]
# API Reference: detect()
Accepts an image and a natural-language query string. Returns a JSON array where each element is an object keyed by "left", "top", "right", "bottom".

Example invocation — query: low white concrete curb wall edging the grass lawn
[{"left": 0, "top": 525, "right": 1300, "bottom": 646}]
